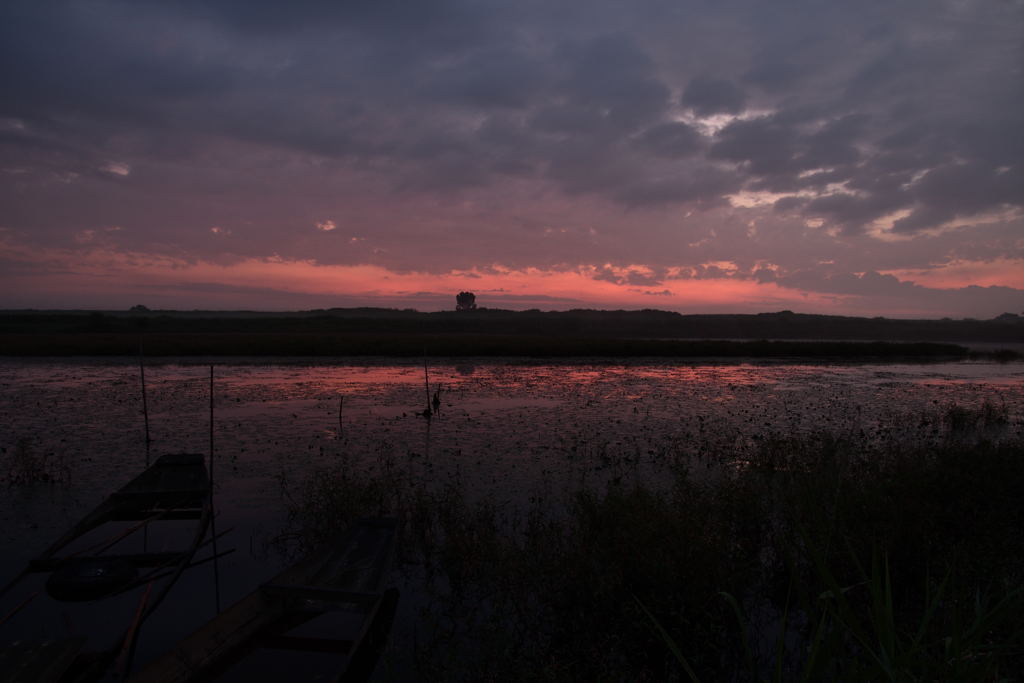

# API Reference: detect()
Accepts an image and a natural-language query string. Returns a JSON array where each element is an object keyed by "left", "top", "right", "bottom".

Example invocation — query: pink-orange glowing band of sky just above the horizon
[{"left": 0, "top": 238, "right": 1024, "bottom": 317}]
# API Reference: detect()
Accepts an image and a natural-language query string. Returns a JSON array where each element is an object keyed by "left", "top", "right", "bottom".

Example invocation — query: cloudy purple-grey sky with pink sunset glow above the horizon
[{"left": 0, "top": 0, "right": 1024, "bottom": 318}]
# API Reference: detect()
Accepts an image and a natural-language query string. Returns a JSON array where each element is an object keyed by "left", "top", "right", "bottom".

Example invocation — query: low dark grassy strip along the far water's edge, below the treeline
[{"left": 0, "top": 332, "right": 1007, "bottom": 360}]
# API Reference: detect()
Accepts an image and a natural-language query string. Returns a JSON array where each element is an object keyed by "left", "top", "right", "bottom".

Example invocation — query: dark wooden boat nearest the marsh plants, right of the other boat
[{"left": 130, "top": 518, "right": 398, "bottom": 683}]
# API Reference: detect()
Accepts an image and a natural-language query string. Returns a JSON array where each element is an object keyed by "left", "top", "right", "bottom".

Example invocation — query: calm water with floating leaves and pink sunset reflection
[{"left": 0, "top": 359, "right": 1024, "bottom": 679}]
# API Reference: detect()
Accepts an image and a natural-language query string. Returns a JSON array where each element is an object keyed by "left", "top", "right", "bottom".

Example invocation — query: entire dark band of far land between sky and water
[{"left": 0, "top": 308, "right": 1024, "bottom": 359}]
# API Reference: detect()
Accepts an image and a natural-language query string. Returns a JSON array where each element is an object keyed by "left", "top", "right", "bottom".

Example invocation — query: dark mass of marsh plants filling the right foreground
[{"left": 291, "top": 404, "right": 1024, "bottom": 681}]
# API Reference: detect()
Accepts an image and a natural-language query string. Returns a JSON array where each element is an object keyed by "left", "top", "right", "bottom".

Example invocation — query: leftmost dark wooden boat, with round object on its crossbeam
[{"left": 0, "top": 454, "right": 211, "bottom": 683}]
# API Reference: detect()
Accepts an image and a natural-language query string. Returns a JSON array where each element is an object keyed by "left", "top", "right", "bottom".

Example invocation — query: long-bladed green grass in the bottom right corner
[{"left": 647, "top": 557, "right": 1024, "bottom": 683}]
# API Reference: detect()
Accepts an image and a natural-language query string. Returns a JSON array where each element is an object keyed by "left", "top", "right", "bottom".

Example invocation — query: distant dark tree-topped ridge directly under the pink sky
[{"left": 0, "top": 308, "right": 1024, "bottom": 344}]
